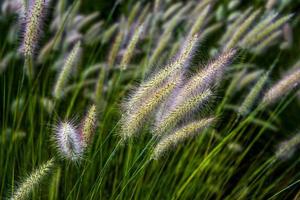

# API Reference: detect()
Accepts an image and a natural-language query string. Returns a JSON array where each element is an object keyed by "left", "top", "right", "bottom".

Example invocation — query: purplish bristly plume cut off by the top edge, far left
[{"left": 21, "top": 0, "right": 50, "bottom": 58}]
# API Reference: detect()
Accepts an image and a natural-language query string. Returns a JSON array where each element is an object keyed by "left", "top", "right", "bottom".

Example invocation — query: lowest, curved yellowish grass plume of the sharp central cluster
[{"left": 152, "top": 118, "right": 215, "bottom": 160}]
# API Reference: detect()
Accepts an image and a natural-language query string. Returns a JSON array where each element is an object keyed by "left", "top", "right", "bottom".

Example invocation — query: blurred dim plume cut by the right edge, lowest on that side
[{"left": 275, "top": 133, "right": 300, "bottom": 160}]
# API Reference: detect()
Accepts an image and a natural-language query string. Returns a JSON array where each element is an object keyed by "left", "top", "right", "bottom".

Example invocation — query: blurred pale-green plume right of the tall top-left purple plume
[{"left": 53, "top": 42, "right": 80, "bottom": 99}]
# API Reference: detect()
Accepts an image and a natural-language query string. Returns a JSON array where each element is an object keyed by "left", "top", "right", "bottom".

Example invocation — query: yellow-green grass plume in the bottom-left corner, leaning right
[{"left": 10, "top": 158, "right": 55, "bottom": 200}]
